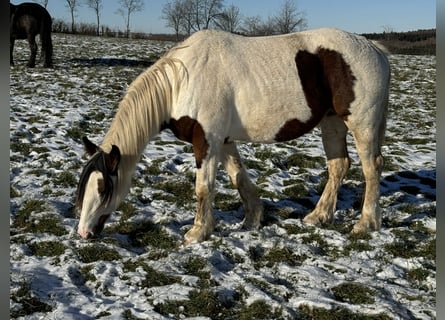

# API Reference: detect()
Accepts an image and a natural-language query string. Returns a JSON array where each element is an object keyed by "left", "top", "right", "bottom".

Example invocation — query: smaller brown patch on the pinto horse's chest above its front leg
[{"left": 161, "top": 116, "right": 209, "bottom": 169}]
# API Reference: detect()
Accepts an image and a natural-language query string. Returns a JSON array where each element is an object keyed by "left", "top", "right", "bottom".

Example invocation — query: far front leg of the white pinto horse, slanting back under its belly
[{"left": 221, "top": 142, "right": 263, "bottom": 229}]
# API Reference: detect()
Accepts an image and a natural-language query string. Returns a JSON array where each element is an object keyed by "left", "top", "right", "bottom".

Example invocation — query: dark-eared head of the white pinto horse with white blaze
[{"left": 76, "top": 137, "right": 120, "bottom": 239}]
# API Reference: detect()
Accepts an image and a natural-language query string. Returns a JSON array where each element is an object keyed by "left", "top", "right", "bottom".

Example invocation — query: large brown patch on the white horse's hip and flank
[{"left": 295, "top": 48, "right": 355, "bottom": 120}]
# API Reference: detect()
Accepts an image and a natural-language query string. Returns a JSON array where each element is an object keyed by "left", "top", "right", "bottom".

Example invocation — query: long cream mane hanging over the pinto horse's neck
[{"left": 101, "top": 57, "right": 186, "bottom": 202}]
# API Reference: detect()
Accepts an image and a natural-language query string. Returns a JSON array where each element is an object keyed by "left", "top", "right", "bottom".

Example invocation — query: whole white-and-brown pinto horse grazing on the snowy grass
[{"left": 76, "top": 28, "right": 390, "bottom": 243}]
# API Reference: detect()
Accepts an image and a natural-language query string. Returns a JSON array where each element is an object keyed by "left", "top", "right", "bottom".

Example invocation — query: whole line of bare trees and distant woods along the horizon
[{"left": 34, "top": 0, "right": 436, "bottom": 55}]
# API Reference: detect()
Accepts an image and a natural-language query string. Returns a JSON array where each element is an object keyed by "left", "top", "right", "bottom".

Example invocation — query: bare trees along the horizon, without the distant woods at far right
[{"left": 34, "top": 0, "right": 307, "bottom": 40}]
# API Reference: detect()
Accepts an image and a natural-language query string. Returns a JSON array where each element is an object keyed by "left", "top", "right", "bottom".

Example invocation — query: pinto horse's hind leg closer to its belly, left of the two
[{"left": 303, "top": 115, "right": 350, "bottom": 225}]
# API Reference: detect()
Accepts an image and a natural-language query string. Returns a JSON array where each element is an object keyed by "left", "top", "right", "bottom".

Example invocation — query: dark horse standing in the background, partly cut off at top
[{"left": 9, "top": 2, "right": 53, "bottom": 68}]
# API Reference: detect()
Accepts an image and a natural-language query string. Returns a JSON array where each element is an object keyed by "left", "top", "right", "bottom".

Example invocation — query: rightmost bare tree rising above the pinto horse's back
[{"left": 273, "top": 0, "right": 306, "bottom": 34}]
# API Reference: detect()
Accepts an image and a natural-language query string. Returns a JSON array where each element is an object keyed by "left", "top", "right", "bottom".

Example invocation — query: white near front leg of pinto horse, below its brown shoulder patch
[{"left": 184, "top": 155, "right": 217, "bottom": 244}]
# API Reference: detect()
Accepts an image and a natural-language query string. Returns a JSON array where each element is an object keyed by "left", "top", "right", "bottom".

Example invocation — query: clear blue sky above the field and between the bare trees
[{"left": 30, "top": 0, "right": 436, "bottom": 33}]
